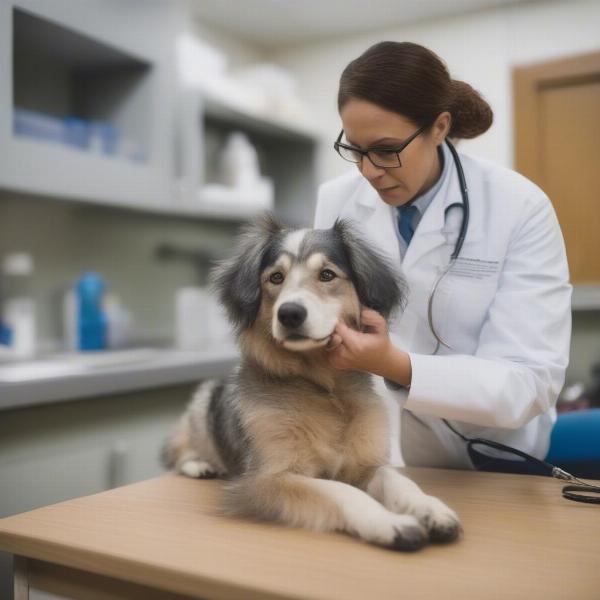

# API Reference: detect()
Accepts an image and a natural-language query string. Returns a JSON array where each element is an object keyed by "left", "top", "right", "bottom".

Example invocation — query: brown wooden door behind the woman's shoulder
[{"left": 514, "top": 53, "right": 600, "bottom": 284}]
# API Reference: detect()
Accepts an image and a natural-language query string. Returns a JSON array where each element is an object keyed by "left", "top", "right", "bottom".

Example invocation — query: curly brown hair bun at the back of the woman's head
[{"left": 448, "top": 79, "right": 494, "bottom": 139}]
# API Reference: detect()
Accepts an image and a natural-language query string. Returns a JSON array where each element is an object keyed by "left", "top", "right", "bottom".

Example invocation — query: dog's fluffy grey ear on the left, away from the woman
[{"left": 209, "top": 212, "right": 284, "bottom": 333}]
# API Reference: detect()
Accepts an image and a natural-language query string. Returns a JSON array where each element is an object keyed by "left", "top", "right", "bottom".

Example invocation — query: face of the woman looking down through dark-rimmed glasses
[{"left": 340, "top": 98, "right": 450, "bottom": 206}]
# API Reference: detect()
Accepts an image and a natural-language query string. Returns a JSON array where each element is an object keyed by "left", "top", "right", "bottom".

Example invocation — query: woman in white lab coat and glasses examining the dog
[{"left": 314, "top": 42, "right": 572, "bottom": 472}]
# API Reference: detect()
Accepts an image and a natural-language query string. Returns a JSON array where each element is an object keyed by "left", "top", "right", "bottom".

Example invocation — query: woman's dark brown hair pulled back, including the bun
[{"left": 338, "top": 42, "right": 494, "bottom": 138}]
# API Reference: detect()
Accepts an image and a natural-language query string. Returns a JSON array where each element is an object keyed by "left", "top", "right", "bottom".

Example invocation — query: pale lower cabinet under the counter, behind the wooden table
[{"left": 0, "top": 382, "right": 196, "bottom": 599}]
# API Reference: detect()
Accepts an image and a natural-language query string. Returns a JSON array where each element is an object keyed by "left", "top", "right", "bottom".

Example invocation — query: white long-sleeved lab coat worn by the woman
[{"left": 314, "top": 144, "right": 572, "bottom": 469}]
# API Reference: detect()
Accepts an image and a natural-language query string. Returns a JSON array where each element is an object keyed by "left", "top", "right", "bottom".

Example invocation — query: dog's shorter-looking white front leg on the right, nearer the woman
[{"left": 360, "top": 466, "right": 462, "bottom": 542}]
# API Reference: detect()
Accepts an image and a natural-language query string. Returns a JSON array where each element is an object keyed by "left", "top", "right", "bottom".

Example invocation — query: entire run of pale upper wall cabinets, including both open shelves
[{"left": 0, "top": 0, "right": 319, "bottom": 225}]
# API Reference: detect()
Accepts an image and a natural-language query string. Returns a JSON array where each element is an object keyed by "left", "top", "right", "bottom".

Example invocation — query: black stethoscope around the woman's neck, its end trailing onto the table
[{"left": 427, "top": 139, "right": 600, "bottom": 504}]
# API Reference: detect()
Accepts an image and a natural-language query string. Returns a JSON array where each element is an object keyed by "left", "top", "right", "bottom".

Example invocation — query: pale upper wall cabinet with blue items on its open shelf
[{"left": 0, "top": 0, "right": 174, "bottom": 206}]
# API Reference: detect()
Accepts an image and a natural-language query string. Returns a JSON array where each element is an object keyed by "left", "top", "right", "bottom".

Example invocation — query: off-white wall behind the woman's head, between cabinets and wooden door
[{"left": 270, "top": 0, "right": 600, "bottom": 181}]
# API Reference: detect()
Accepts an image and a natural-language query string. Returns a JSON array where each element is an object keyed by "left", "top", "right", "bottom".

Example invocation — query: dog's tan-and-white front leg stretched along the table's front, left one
[{"left": 219, "top": 472, "right": 428, "bottom": 550}]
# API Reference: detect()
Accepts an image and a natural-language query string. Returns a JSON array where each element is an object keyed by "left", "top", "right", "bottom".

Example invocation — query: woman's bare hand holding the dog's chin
[{"left": 326, "top": 308, "right": 412, "bottom": 386}]
